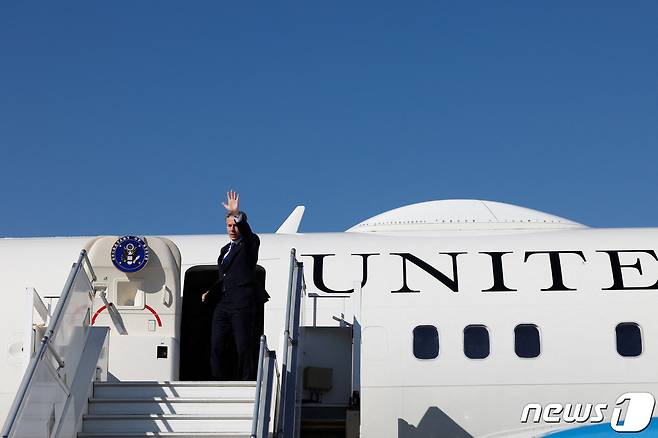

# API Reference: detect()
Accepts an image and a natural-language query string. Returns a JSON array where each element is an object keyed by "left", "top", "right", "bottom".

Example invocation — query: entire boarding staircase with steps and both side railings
[{"left": 0, "top": 249, "right": 304, "bottom": 438}]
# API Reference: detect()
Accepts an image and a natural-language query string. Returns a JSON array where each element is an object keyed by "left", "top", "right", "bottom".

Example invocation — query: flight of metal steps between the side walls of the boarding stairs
[{"left": 78, "top": 382, "right": 256, "bottom": 438}]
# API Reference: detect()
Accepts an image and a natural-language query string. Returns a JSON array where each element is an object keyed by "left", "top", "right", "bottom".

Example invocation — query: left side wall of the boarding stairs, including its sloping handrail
[{"left": 2, "top": 251, "right": 107, "bottom": 438}]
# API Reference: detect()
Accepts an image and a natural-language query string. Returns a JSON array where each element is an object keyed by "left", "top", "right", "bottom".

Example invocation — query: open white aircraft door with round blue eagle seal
[{"left": 87, "top": 236, "right": 181, "bottom": 380}]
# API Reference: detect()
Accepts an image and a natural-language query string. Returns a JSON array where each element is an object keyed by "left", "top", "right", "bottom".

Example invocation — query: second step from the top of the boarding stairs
[{"left": 89, "top": 397, "right": 254, "bottom": 415}]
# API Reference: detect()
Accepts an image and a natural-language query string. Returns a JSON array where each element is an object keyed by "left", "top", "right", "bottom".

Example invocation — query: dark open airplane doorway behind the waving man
[{"left": 180, "top": 265, "right": 265, "bottom": 381}]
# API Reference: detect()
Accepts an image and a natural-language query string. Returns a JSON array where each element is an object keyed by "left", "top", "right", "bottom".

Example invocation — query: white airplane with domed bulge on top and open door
[{"left": 0, "top": 199, "right": 658, "bottom": 438}]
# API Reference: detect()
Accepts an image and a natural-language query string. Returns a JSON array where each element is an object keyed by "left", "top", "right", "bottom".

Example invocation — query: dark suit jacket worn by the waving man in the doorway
[{"left": 209, "top": 213, "right": 269, "bottom": 310}]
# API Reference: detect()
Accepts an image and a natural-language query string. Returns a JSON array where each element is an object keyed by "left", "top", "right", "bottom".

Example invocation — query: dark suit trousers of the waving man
[{"left": 210, "top": 303, "right": 256, "bottom": 380}]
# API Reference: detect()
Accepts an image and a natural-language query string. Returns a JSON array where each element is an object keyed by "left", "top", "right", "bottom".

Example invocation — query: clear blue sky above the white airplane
[{"left": 0, "top": 0, "right": 658, "bottom": 236}]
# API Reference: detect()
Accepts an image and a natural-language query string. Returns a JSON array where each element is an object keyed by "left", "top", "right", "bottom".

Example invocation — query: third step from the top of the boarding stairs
[{"left": 82, "top": 414, "right": 251, "bottom": 435}]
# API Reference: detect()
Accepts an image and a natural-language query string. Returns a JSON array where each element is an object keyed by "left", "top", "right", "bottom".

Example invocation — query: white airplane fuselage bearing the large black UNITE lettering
[{"left": 0, "top": 202, "right": 658, "bottom": 437}]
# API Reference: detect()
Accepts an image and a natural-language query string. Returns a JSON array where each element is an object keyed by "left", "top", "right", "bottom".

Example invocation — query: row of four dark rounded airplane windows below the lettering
[{"left": 413, "top": 322, "right": 642, "bottom": 359}]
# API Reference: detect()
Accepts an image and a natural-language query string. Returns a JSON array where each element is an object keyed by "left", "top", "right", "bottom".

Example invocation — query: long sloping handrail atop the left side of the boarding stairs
[{"left": 1, "top": 249, "right": 96, "bottom": 438}]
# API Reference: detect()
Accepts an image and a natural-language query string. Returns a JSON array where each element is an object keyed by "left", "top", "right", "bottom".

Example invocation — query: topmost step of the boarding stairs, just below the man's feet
[{"left": 93, "top": 381, "right": 256, "bottom": 399}]
